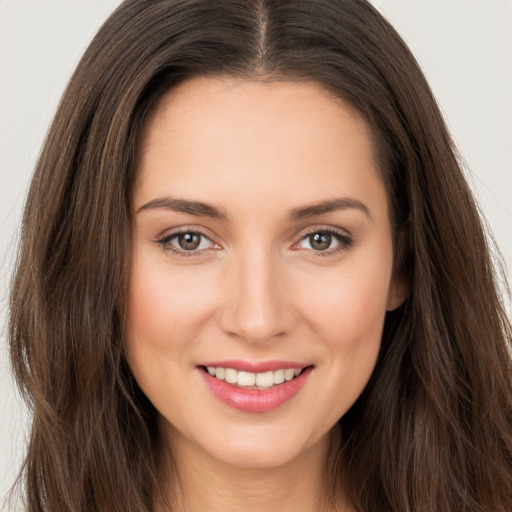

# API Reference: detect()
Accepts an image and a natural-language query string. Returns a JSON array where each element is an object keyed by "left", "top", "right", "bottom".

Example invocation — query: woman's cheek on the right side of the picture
[{"left": 292, "top": 248, "right": 392, "bottom": 412}]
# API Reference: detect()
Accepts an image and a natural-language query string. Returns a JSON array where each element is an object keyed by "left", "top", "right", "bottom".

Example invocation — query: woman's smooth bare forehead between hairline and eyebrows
[{"left": 136, "top": 77, "right": 382, "bottom": 217}]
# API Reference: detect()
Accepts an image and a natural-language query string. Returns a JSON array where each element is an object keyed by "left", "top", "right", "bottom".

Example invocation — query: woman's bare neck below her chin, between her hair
[{"left": 155, "top": 424, "right": 345, "bottom": 512}]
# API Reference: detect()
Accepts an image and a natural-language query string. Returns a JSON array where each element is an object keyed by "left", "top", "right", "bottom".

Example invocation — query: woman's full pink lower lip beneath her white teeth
[{"left": 199, "top": 366, "right": 312, "bottom": 412}]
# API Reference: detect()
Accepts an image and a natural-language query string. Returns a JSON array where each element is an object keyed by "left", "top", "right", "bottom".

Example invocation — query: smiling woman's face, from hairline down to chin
[{"left": 126, "top": 78, "right": 402, "bottom": 467}]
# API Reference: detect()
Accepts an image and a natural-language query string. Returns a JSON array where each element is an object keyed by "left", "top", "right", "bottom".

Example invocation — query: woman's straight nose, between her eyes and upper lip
[{"left": 220, "top": 249, "right": 294, "bottom": 344}]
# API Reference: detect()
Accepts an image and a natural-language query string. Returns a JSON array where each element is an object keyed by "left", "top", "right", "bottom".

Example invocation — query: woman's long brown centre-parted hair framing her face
[{"left": 9, "top": 0, "right": 512, "bottom": 512}]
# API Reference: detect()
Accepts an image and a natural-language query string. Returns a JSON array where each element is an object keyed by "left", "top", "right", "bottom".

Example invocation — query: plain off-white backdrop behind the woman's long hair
[{"left": 0, "top": 0, "right": 512, "bottom": 508}]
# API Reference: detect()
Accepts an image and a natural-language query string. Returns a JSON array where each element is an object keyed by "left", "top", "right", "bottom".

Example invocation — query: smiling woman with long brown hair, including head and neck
[{"left": 10, "top": 0, "right": 512, "bottom": 512}]
